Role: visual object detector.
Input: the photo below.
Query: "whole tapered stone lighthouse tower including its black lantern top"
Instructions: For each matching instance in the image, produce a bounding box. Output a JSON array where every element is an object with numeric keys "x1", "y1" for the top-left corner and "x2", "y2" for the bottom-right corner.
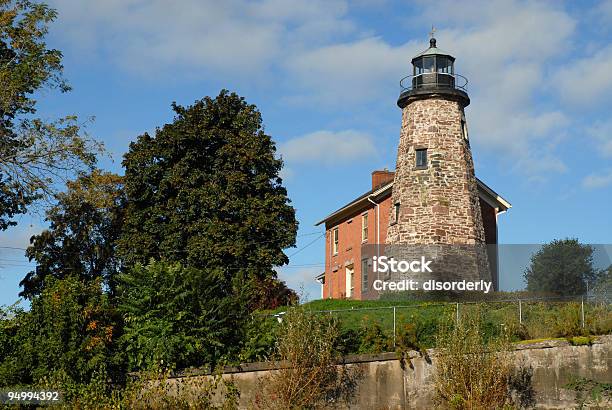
[{"x1": 386, "y1": 38, "x2": 490, "y2": 280}]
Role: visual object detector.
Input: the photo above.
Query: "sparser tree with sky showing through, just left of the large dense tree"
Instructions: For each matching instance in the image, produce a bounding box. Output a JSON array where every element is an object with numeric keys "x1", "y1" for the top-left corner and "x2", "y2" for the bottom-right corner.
[{"x1": 20, "y1": 170, "x2": 124, "y2": 298}]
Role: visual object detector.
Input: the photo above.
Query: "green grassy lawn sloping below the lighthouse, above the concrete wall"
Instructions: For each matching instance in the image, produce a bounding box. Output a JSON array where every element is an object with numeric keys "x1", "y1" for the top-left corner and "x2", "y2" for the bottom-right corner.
[{"x1": 290, "y1": 299, "x2": 612, "y2": 345}]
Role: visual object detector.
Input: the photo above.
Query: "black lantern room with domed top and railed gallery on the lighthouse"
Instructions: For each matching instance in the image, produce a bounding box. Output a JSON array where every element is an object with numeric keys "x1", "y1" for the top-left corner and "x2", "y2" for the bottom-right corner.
[{"x1": 397, "y1": 38, "x2": 470, "y2": 108}]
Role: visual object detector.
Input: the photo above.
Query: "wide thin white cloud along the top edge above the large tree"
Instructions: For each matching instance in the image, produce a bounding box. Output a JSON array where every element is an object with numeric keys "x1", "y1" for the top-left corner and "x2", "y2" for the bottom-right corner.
[{"x1": 51, "y1": 0, "x2": 353, "y2": 78}]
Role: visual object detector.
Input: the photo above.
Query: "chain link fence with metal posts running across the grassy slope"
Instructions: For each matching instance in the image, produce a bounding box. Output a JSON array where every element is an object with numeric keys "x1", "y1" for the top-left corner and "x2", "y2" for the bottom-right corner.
[{"x1": 274, "y1": 294, "x2": 612, "y2": 347}]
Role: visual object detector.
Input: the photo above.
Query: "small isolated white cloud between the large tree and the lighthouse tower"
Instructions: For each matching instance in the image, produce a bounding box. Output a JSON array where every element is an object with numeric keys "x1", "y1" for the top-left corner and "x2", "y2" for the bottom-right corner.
[{"x1": 279, "y1": 130, "x2": 377, "y2": 166}]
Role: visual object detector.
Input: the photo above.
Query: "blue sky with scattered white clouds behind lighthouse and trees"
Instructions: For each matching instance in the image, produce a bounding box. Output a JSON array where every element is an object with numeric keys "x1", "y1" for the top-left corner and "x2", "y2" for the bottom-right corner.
[{"x1": 0, "y1": 0, "x2": 612, "y2": 304}]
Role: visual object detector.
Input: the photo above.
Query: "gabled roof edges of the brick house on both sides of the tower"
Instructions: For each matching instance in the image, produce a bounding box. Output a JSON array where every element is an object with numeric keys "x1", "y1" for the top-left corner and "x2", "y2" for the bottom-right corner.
[{"x1": 315, "y1": 178, "x2": 512, "y2": 226}]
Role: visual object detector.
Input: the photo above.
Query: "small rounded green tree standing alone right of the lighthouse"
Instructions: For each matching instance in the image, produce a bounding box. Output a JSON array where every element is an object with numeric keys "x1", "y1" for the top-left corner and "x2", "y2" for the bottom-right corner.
[{"x1": 524, "y1": 239, "x2": 597, "y2": 296}]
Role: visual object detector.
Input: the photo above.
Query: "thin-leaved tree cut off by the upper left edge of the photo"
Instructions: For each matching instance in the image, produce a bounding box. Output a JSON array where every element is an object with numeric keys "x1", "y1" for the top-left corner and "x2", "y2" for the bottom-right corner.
[{"x1": 0, "y1": 0, "x2": 101, "y2": 230}]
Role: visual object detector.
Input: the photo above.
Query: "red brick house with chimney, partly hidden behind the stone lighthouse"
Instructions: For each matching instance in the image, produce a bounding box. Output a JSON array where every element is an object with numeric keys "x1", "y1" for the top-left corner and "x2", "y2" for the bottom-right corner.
[{"x1": 316, "y1": 170, "x2": 511, "y2": 300}]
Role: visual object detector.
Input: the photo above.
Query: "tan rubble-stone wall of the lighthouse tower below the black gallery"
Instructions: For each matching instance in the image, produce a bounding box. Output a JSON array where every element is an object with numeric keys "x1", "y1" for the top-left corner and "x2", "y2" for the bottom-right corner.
[{"x1": 386, "y1": 94, "x2": 490, "y2": 279}]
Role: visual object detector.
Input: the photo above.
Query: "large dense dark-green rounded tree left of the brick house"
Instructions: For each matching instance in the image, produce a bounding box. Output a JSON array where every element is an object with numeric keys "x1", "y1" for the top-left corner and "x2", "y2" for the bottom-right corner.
[{"x1": 119, "y1": 90, "x2": 297, "y2": 298}]
